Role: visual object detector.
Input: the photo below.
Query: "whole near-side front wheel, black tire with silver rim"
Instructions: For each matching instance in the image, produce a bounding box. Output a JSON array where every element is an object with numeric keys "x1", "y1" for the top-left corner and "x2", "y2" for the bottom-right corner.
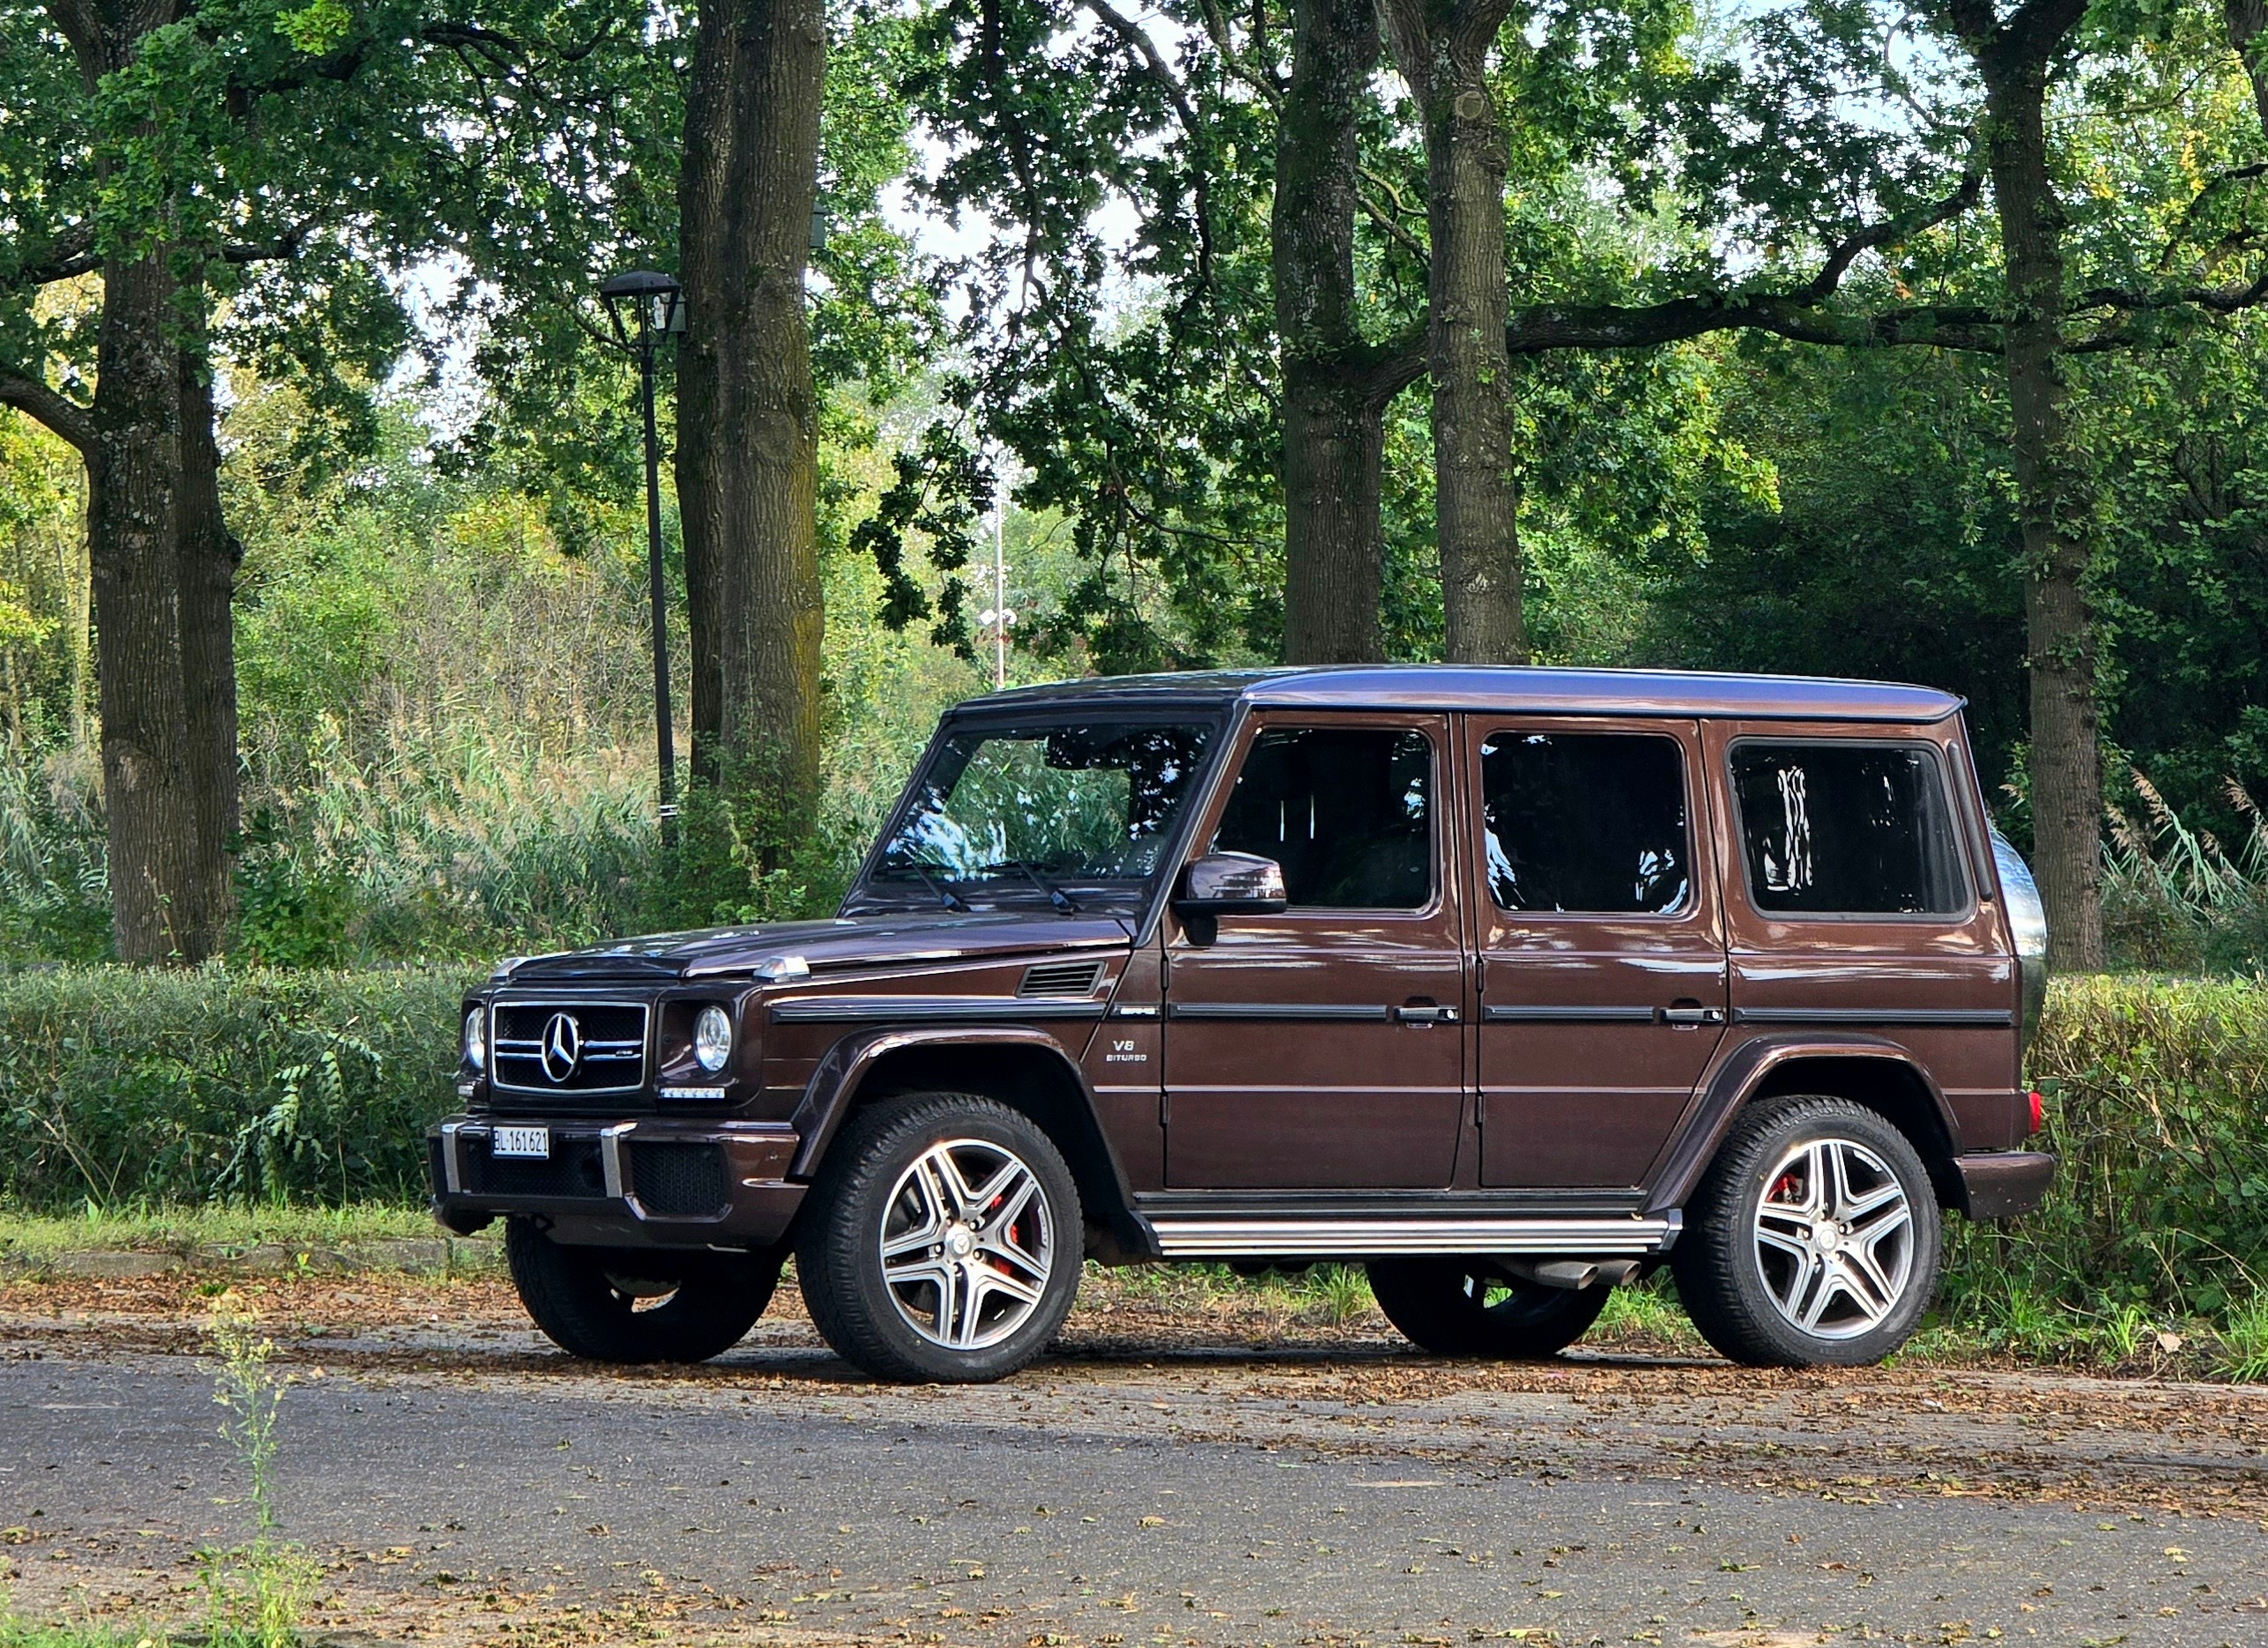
[{"x1": 796, "y1": 1092, "x2": 1084, "y2": 1384}]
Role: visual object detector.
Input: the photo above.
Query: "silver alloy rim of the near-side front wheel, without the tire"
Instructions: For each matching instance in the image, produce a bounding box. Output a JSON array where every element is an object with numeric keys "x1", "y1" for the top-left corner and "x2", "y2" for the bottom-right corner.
[{"x1": 878, "y1": 1139, "x2": 1056, "y2": 1351}]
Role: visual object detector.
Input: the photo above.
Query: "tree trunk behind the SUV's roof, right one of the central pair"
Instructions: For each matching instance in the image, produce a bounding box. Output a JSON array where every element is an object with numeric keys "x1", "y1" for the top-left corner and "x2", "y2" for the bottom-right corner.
[{"x1": 1382, "y1": 0, "x2": 1529, "y2": 663}]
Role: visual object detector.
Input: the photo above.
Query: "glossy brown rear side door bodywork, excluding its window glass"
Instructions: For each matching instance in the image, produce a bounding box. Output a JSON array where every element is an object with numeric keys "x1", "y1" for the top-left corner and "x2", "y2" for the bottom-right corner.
[{"x1": 1458, "y1": 715, "x2": 1728, "y2": 1187}]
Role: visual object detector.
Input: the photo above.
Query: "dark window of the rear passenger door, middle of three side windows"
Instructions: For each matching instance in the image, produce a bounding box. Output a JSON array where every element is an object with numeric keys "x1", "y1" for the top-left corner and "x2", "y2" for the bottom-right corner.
[{"x1": 1481, "y1": 733, "x2": 1692, "y2": 915}]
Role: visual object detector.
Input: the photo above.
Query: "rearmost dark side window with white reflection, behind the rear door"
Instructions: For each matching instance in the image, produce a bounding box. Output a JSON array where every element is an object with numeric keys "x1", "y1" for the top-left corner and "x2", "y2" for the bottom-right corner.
[{"x1": 1733, "y1": 740, "x2": 1968, "y2": 915}]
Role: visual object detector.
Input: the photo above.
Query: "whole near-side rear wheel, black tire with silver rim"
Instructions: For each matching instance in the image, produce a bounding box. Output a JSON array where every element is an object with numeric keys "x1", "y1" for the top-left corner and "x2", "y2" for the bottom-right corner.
[{"x1": 1669, "y1": 1095, "x2": 1944, "y2": 1367}]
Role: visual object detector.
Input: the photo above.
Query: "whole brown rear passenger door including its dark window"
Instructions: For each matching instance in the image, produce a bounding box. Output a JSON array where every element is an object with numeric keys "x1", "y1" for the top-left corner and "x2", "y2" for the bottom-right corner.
[{"x1": 1465, "y1": 715, "x2": 1728, "y2": 1190}]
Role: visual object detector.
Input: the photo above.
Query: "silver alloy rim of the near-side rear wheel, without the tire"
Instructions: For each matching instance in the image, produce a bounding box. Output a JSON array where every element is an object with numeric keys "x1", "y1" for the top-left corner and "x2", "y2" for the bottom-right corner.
[{"x1": 1753, "y1": 1139, "x2": 1914, "y2": 1340}]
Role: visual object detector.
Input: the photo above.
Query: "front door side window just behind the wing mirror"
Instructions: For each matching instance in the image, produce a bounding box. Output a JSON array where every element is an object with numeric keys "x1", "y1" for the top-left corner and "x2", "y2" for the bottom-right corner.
[{"x1": 1213, "y1": 726, "x2": 1434, "y2": 910}]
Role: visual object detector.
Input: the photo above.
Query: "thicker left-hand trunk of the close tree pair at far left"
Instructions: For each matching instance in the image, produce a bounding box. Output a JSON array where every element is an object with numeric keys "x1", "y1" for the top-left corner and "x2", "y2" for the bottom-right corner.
[{"x1": 86, "y1": 252, "x2": 209, "y2": 962}]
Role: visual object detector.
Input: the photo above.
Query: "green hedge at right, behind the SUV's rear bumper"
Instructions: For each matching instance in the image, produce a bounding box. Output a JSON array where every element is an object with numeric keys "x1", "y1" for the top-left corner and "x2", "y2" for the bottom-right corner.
[{"x1": 1951, "y1": 978, "x2": 2268, "y2": 1317}]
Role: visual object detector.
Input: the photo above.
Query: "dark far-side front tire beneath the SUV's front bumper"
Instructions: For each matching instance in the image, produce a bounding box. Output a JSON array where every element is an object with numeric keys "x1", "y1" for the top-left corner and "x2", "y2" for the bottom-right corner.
[{"x1": 503, "y1": 1219, "x2": 787, "y2": 1362}]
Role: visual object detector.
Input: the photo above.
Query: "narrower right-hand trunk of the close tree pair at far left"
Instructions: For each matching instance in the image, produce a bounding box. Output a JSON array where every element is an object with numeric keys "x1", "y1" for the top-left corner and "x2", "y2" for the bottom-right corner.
[{"x1": 174, "y1": 313, "x2": 245, "y2": 961}]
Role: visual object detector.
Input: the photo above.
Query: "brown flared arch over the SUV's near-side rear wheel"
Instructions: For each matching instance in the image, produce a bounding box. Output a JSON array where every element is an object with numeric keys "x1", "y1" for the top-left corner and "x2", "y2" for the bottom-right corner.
[{"x1": 1647, "y1": 1036, "x2": 1967, "y2": 1214}]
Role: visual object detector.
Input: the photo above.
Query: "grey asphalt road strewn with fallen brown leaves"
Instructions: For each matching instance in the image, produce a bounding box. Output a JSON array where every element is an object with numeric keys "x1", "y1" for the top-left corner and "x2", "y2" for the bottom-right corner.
[{"x1": 0, "y1": 1312, "x2": 2268, "y2": 1648}]
